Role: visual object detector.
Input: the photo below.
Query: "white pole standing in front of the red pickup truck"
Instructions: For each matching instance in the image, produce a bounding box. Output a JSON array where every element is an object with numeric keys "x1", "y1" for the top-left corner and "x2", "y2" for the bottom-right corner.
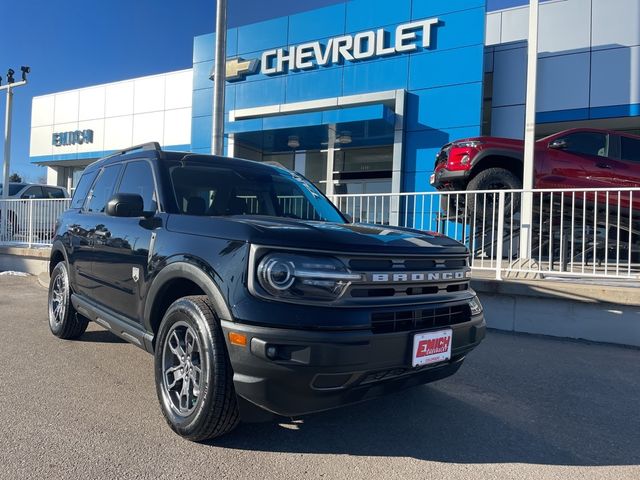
[{"x1": 519, "y1": 0, "x2": 538, "y2": 259}]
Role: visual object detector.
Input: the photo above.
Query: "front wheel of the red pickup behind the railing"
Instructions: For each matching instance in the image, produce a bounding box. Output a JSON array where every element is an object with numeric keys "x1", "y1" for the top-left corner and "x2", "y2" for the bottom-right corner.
[{"x1": 467, "y1": 168, "x2": 522, "y2": 220}]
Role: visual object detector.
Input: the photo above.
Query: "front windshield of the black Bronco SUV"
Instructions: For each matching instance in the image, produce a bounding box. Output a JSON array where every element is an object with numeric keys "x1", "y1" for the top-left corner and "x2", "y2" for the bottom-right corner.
[{"x1": 170, "y1": 164, "x2": 345, "y2": 223}]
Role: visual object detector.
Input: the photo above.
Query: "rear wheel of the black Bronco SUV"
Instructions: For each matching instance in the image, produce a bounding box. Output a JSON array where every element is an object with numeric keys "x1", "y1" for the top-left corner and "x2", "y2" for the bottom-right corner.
[{"x1": 49, "y1": 262, "x2": 89, "y2": 340}]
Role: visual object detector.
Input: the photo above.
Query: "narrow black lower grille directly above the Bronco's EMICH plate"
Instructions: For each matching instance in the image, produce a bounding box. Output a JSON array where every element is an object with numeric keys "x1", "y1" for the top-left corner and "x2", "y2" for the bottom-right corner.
[{"x1": 371, "y1": 304, "x2": 471, "y2": 333}]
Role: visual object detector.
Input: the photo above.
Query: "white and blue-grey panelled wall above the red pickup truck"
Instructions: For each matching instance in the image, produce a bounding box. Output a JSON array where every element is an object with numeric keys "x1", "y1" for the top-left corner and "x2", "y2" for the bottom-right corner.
[{"x1": 486, "y1": 0, "x2": 640, "y2": 138}]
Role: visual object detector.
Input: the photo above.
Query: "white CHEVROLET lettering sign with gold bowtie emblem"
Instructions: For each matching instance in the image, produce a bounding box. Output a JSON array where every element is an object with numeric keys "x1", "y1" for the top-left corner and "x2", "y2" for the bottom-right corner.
[{"x1": 220, "y1": 18, "x2": 439, "y2": 81}]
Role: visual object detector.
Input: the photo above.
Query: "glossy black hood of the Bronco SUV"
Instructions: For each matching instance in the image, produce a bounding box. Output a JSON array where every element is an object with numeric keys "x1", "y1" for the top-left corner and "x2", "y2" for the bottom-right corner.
[{"x1": 167, "y1": 215, "x2": 467, "y2": 255}]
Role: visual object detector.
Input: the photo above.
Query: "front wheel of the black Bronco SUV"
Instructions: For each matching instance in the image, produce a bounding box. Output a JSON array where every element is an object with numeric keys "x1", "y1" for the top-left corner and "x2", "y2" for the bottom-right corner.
[{"x1": 155, "y1": 296, "x2": 240, "y2": 441}]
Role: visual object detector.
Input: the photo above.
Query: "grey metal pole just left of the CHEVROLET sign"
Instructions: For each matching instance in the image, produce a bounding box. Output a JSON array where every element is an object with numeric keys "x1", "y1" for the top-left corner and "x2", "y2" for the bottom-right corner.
[{"x1": 211, "y1": 0, "x2": 227, "y2": 155}]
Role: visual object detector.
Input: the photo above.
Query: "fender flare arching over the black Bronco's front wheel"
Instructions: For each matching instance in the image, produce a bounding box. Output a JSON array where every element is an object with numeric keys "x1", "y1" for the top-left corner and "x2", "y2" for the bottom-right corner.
[{"x1": 143, "y1": 260, "x2": 233, "y2": 333}]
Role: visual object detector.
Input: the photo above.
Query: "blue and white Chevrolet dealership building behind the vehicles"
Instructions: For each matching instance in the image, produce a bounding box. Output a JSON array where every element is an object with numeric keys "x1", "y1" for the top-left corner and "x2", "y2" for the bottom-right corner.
[{"x1": 30, "y1": 0, "x2": 640, "y2": 194}]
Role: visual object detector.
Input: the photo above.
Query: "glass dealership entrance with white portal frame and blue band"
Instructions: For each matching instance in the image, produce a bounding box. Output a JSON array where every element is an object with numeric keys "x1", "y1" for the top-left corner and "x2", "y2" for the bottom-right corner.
[{"x1": 226, "y1": 90, "x2": 405, "y2": 196}]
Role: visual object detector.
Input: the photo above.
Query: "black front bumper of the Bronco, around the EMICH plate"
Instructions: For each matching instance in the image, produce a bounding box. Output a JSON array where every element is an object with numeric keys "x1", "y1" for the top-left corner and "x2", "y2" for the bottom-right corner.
[{"x1": 222, "y1": 314, "x2": 486, "y2": 417}]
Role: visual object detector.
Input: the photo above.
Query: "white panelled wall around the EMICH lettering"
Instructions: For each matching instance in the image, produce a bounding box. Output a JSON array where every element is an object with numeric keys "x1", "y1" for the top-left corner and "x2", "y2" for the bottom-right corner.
[{"x1": 30, "y1": 70, "x2": 193, "y2": 161}]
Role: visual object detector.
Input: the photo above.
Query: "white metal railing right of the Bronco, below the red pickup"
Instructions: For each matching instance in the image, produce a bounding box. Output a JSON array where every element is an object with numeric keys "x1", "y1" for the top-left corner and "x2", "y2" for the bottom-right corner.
[{"x1": 332, "y1": 188, "x2": 640, "y2": 280}]
